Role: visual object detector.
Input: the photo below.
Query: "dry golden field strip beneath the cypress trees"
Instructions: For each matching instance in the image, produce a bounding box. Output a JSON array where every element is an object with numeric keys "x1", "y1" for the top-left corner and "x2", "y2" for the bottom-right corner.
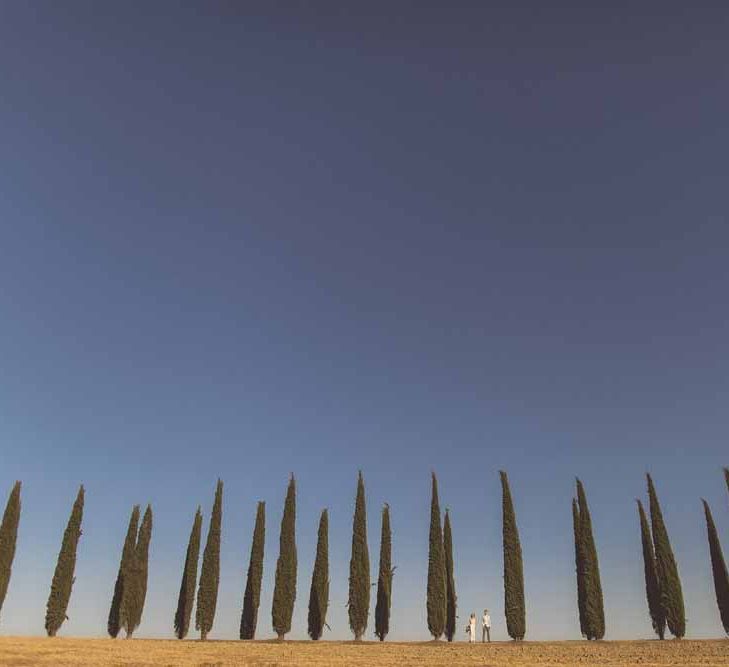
[{"x1": 0, "y1": 637, "x2": 729, "y2": 667}]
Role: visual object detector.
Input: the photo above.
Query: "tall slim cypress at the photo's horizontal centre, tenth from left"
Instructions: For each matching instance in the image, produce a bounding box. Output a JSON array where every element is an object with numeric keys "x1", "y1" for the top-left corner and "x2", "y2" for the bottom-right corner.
[{"x1": 348, "y1": 470, "x2": 370, "y2": 641}]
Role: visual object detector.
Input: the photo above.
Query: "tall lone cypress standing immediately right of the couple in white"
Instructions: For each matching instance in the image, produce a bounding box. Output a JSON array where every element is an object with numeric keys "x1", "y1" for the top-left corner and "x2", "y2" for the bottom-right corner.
[{"x1": 499, "y1": 470, "x2": 526, "y2": 641}]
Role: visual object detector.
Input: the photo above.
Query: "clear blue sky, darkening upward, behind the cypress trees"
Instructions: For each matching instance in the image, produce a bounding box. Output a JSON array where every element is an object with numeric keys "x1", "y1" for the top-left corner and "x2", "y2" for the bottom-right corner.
[{"x1": 0, "y1": 1, "x2": 729, "y2": 640}]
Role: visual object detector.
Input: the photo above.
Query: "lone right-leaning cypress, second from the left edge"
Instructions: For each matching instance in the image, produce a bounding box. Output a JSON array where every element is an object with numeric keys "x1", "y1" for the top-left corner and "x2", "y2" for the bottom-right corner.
[{"x1": 46, "y1": 485, "x2": 84, "y2": 637}]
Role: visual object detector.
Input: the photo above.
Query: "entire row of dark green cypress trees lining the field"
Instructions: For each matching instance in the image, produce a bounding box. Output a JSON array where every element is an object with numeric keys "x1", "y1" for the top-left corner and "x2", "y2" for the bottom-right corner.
[{"x1": 0, "y1": 468, "x2": 729, "y2": 641}]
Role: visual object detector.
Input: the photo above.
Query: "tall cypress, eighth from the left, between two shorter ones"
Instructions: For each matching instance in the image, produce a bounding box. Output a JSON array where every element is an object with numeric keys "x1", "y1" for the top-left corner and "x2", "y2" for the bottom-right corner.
[{"x1": 271, "y1": 474, "x2": 297, "y2": 640}]
